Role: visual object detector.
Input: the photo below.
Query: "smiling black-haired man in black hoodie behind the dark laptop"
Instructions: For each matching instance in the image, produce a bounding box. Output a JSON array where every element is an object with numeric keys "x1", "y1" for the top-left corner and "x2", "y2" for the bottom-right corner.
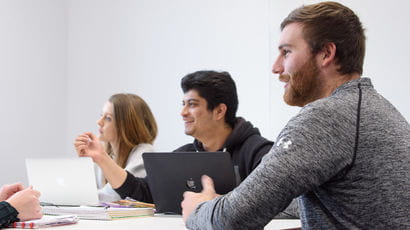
[{"x1": 175, "y1": 71, "x2": 273, "y2": 181}]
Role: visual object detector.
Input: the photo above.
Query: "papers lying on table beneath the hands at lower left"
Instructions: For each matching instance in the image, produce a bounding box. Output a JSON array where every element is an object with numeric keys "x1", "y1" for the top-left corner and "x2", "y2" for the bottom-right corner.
[{"x1": 9, "y1": 215, "x2": 78, "y2": 228}]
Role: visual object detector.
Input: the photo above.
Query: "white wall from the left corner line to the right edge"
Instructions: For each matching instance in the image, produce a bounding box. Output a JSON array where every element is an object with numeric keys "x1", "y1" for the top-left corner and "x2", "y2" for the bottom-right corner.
[{"x1": 67, "y1": 0, "x2": 410, "y2": 155}]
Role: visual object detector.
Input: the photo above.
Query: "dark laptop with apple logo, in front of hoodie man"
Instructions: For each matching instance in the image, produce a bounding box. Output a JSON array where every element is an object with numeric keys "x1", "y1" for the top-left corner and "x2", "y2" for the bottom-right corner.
[{"x1": 142, "y1": 152, "x2": 237, "y2": 214}]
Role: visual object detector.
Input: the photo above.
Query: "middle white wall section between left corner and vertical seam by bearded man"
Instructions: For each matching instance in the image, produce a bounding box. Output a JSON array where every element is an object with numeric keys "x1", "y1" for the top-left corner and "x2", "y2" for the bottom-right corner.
[{"x1": 67, "y1": 0, "x2": 271, "y2": 155}]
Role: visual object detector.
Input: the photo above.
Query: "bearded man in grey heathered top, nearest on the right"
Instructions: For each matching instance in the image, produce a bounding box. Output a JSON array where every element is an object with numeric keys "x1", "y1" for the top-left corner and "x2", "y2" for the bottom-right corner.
[{"x1": 181, "y1": 2, "x2": 410, "y2": 229}]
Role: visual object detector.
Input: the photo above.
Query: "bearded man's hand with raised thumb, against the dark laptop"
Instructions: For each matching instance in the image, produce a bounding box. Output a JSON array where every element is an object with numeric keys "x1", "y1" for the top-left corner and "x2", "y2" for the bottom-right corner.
[{"x1": 181, "y1": 175, "x2": 220, "y2": 222}]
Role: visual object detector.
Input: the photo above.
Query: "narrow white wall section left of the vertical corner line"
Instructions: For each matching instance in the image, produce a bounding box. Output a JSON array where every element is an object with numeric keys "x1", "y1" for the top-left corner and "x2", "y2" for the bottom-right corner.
[{"x1": 0, "y1": 0, "x2": 67, "y2": 184}]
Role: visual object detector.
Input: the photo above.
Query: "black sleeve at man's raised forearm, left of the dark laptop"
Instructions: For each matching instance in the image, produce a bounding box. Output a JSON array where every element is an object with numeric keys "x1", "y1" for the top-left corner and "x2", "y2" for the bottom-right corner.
[{"x1": 114, "y1": 171, "x2": 153, "y2": 203}]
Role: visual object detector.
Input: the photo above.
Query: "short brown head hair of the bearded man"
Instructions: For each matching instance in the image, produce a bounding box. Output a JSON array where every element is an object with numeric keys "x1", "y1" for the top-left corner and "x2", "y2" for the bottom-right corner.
[{"x1": 281, "y1": 2, "x2": 366, "y2": 75}]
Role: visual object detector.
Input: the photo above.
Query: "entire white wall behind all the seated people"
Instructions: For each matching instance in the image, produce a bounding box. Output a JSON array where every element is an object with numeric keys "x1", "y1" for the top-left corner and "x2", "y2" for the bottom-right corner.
[{"x1": 0, "y1": 0, "x2": 410, "y2": 183}]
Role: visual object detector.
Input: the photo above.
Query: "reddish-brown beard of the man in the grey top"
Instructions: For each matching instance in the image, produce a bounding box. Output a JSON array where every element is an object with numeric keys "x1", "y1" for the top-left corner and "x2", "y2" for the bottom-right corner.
[{"x1": 279, "y1": 57, "x2": 321, "y2": 107}]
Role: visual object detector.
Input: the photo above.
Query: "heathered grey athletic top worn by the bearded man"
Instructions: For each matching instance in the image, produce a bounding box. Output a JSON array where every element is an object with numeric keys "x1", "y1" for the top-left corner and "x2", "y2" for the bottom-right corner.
[{"x1": 186, "y1": 78, "x2": 410, "y2": 229}]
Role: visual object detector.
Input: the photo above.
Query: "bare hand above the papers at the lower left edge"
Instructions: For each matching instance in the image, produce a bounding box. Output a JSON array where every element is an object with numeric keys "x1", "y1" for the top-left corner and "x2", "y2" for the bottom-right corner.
[{"x1": 6, "y1": 186, "x2": 43, "y2": 221}]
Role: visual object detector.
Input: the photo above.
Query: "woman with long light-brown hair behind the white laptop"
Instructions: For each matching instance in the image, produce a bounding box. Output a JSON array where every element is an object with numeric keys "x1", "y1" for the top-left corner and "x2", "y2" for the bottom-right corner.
[{"x1": 74, "y1": 94, "x2": 157, "y2": 201}]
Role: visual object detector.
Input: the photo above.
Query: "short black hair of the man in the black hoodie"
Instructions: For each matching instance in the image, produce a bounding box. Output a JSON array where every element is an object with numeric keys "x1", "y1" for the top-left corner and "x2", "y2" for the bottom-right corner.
[{"x1": 181, "y1": 71, "x2": 238, "y2": 128}]
